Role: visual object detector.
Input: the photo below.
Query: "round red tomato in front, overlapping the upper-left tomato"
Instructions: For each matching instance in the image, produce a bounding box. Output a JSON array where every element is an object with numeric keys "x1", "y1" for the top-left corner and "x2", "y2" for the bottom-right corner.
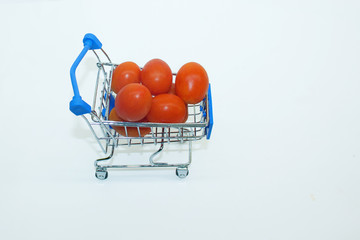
[{"x1": 115, "y1": 83, "x2": 152, "y2": 122}]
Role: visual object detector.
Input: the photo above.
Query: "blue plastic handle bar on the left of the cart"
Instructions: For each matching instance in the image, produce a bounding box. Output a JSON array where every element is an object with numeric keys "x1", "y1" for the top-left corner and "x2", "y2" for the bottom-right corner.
[{"x1": 70, "y1": 33, "x2": 102, "y2": 116}]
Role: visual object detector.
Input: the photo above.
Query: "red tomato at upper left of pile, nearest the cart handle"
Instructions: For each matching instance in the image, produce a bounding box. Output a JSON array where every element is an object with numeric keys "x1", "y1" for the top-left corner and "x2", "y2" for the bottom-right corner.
[{"x1": 111, "y1": 62, "x2": 141, "y2": 93}]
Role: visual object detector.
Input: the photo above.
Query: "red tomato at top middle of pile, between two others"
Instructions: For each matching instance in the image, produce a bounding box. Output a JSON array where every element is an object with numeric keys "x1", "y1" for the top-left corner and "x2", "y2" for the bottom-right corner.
[{"x1": 141, "y1": 59, "x2": 172, "y2": 95}]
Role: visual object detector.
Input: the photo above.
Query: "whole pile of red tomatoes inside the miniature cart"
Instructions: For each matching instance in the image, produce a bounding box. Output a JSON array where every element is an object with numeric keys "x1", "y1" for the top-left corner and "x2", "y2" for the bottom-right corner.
[{"x1": 109, "y1": 59, "x2": 209, "y2": 137}]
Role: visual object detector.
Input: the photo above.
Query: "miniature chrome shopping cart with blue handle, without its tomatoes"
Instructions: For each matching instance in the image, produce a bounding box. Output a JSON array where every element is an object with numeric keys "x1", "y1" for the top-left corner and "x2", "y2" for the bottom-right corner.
[{"x1": 70, "y1": 33, "x2": 213, "y2": 180}]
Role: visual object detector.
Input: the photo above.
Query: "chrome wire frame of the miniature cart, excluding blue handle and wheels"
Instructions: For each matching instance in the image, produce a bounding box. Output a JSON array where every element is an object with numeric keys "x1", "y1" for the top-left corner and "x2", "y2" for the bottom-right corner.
[{"x1": 82, "y1": 49, "x2": 209, "y2": 170}]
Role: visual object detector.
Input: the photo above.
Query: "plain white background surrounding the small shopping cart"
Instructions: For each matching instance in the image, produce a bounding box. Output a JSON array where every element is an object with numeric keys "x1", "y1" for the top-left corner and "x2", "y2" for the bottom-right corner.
[{"x1": 0, "y1": 0, "x2": 360, "y2": 240}]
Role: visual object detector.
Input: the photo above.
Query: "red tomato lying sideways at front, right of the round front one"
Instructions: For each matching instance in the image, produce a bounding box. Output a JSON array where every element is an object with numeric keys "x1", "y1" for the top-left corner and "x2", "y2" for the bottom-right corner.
[{"x1": 146, "y1": 93, "x2": 186, "y2": 123}]
